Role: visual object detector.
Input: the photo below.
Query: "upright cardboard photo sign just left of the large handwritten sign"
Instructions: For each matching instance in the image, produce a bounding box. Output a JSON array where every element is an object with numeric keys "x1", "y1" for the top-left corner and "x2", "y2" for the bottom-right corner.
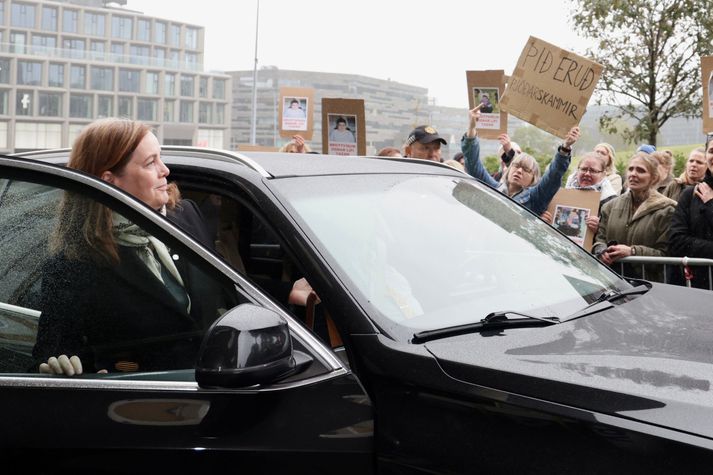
[{"x1": 465, "y1": 70, "x2": 508, "y2": 139}]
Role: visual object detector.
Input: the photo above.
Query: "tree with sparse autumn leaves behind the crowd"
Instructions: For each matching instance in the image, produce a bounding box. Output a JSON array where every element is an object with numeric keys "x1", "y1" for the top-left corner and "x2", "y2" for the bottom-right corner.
[{"x1": 570, "y1": 0, "x2": 713, "y2": 144}]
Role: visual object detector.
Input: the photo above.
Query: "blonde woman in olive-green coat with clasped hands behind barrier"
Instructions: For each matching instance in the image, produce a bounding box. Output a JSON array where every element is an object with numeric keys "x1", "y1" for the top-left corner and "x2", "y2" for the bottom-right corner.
[{"x1": 592, "y1": 152, "x2": 676, "y2": 280}]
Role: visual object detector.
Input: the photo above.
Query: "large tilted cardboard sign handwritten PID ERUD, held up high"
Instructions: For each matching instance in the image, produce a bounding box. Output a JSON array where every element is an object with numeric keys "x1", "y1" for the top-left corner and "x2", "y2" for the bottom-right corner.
[{"x1": 500, "y1": 36, "x2": 603, "y2": 138}]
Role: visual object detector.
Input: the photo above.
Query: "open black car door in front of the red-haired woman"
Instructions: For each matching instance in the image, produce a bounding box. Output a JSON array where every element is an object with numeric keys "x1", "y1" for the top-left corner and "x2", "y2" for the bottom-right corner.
[{"x1": 0, "y1": 159, "x2": 374, "y2": 473}]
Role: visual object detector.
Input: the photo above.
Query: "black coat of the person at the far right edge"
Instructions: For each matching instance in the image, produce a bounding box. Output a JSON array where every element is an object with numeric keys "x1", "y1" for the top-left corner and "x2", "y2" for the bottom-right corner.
[{"x1": 668, "y1": 186, "x2": 713, "y2": 289}]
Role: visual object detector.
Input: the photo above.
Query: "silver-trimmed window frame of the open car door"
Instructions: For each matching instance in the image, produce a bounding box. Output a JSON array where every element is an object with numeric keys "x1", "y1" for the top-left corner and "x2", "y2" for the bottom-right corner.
[{"x1": 0, "y1": 156, "x2": 349, "y2": 391}]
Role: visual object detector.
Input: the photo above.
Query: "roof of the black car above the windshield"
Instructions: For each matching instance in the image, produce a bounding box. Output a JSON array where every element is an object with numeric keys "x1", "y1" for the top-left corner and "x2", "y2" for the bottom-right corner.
[{"x1": 13, "y1": 145, "x2": 463, "y2": 178}]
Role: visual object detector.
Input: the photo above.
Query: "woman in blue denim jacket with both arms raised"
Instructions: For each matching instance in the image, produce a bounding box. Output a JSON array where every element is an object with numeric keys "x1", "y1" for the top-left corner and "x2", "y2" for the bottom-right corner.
[{"x1": 461, "y1": 106, "x2": 579, "y2": 215}]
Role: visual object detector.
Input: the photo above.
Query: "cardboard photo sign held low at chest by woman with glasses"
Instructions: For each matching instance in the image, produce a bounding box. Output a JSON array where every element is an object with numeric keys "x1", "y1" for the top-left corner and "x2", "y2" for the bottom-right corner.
[{"x1": 547, "y1": 188, "x2": 602, "y2": 251}]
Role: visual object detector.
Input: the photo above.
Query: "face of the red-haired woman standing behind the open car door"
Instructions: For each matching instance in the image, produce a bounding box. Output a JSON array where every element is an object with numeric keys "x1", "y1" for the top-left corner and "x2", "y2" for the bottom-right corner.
[{"x1": 107, "y1": 133, "x2": 169, "y2": 209}]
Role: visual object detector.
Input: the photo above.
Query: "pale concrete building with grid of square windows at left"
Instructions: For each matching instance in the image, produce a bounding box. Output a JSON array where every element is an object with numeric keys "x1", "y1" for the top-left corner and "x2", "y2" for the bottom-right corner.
[{"x1": 0, "y1": 0, "x2": 232, "y2": 152}]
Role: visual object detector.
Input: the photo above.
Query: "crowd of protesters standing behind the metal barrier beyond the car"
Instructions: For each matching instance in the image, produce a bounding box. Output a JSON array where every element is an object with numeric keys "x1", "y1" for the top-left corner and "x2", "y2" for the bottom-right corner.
[{"x1": 379, "y1": 106, "x2": 713, "y2": 289}]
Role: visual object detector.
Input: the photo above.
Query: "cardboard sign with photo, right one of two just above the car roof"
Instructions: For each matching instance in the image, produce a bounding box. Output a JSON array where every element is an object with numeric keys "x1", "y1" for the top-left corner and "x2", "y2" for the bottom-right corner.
[{"x1": 322, "y1": 98, "x2": 366, "y2": 155}]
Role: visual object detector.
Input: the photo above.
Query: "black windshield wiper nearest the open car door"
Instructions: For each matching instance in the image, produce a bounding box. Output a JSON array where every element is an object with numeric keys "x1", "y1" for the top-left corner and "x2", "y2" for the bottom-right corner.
[{"x1": 411, "y1": 310, "x2": 560, "y2": 343}]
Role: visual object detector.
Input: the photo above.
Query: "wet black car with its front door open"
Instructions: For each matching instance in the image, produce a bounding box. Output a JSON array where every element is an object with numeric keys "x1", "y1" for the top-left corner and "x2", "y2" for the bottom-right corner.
[{"x1": 0, "y1": 147, "x2": 713, "y2": 474}]
